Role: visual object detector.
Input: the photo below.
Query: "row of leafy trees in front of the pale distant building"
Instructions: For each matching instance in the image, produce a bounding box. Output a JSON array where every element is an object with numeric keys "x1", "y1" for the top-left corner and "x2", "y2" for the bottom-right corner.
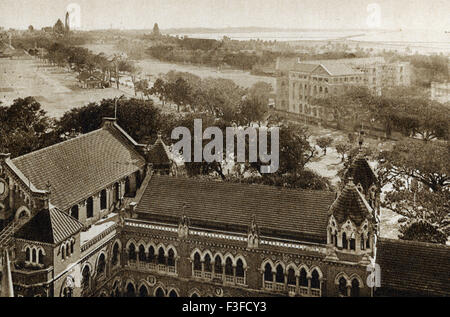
[{"x1": 312, "y1": 87, "x2": 450, "y2": 141}]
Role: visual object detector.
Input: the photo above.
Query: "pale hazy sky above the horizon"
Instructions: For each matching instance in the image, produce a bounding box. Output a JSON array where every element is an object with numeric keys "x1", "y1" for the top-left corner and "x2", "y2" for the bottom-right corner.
[{"x1": 0, "y1": 0, "x2": 450, "y2": 30}]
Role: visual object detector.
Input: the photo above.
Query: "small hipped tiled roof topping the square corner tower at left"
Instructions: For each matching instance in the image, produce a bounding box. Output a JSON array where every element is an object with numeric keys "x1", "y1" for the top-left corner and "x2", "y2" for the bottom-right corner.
[{"x1": 14, "y1": 207, "x2": 83, "y2": 244}]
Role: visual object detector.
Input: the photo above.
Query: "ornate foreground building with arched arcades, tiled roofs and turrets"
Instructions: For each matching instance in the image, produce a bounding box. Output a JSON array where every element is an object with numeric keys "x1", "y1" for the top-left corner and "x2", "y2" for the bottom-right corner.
[{"x1": 0, "y1": 119, "x2": 450, "y2": 297}]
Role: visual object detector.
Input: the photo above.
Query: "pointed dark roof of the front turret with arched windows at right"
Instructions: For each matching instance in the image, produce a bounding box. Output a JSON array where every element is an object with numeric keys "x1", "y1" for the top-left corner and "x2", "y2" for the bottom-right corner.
[{"x1": 330, "y1": 181, "x2": 372, "y2": 226}]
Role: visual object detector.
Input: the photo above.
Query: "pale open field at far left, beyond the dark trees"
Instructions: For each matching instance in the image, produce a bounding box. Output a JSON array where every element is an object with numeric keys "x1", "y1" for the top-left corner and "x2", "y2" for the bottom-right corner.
[{"x1": 0, "y1": 58, "x2": 134, "y2": 117}]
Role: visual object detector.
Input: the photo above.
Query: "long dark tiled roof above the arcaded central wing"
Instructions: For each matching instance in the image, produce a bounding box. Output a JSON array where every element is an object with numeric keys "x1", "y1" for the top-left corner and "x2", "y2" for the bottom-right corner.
[{"x1": 136, "y1": 175, "x2": 335, "y2": 243}]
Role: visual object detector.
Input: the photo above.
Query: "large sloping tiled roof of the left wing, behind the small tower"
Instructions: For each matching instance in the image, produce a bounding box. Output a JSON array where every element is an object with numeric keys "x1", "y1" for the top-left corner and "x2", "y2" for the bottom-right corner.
[{"x1": 12, "y1": 127, "x2": 145, "y2": 210}]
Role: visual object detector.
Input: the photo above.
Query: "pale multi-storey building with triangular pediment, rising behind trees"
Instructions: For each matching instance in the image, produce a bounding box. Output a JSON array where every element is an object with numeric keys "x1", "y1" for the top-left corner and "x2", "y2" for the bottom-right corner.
[{"x1": 275, "y1": 57, "x2": 410, "y2": 122}]
